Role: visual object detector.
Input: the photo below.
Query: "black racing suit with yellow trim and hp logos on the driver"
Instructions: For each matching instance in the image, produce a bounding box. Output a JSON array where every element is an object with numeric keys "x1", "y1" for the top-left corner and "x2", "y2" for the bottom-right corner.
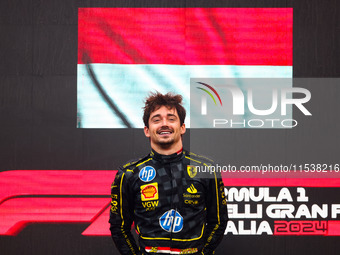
[{"x1": 109, "y1": 150, "x2": 228, "y2": 254}]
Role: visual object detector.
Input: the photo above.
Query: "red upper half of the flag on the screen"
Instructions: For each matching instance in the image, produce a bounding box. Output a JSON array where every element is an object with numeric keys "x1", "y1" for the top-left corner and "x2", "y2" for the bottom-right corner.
[{"x1": 78, "y1": 8, "x2": 293, "y2": 66}]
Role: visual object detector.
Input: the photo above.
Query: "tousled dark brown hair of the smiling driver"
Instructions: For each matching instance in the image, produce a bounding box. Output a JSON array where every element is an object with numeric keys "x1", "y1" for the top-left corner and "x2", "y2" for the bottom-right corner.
[{"x1": 143, "y1": 92, "x2": 186, "y2": 128}]
